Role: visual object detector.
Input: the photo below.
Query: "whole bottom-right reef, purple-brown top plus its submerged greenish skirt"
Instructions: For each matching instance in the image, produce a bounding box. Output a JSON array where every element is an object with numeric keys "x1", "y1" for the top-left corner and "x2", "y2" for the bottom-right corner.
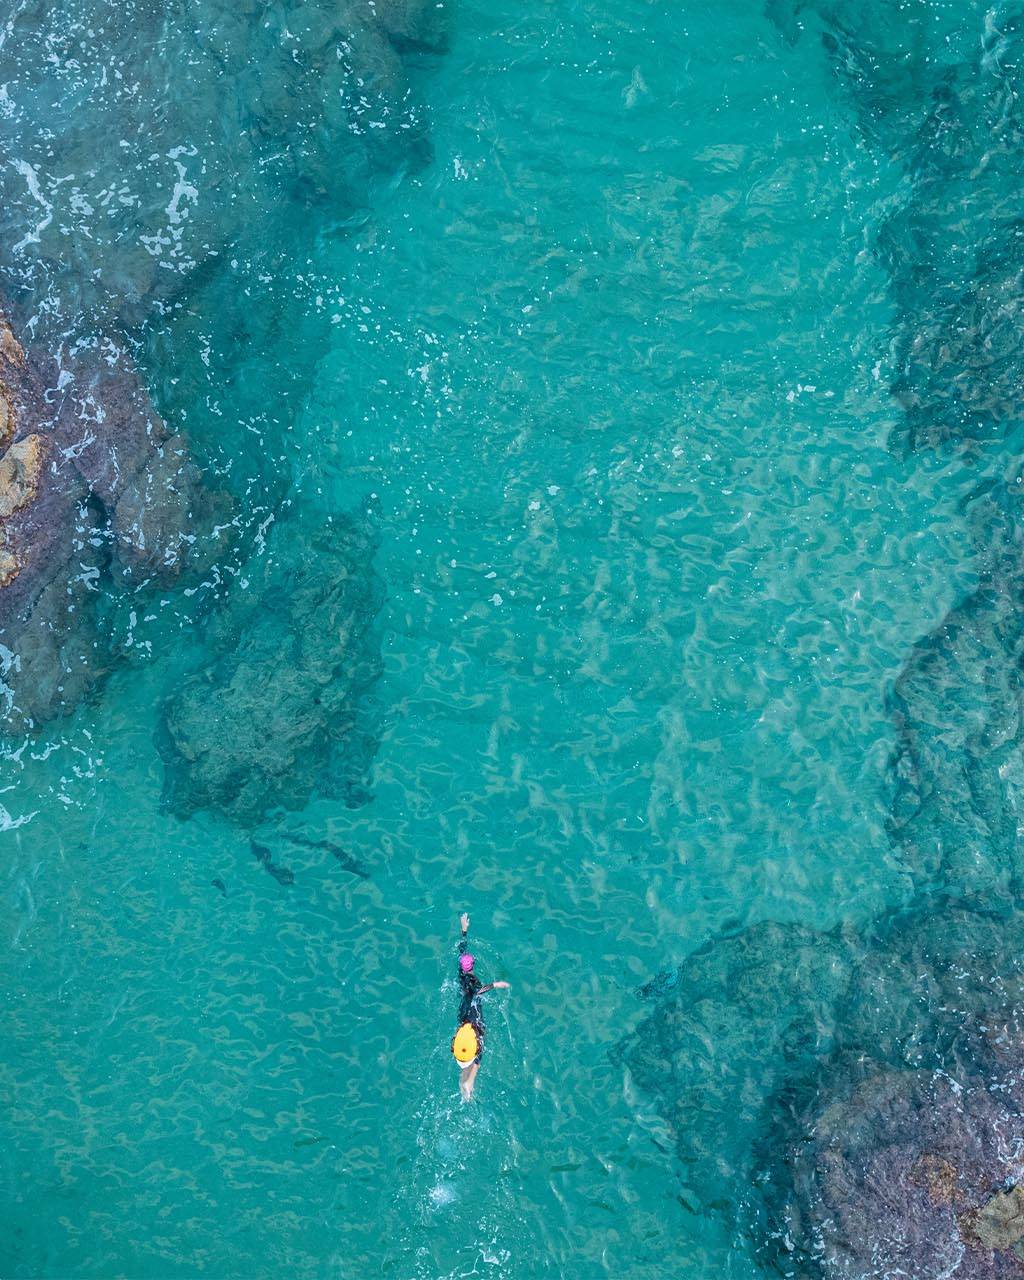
[{"x1": 617, "y1": 901, "x2": 1024, "y2": 1280}]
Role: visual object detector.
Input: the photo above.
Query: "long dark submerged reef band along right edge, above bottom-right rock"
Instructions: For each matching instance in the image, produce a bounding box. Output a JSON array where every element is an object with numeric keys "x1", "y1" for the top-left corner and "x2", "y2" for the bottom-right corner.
[{"x1": 767, "y1": 0, "x2": 1024, "y2": 892}]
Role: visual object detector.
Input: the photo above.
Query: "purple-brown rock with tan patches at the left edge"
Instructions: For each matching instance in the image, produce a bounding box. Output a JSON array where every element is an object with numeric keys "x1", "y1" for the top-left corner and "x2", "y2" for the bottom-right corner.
[{"x1": 0, "y1": 303, "x2": 227, "y2": 733}]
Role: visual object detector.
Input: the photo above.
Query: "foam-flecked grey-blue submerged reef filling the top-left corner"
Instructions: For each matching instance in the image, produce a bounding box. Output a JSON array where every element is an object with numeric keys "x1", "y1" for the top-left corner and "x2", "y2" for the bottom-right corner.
[{"x1": 0, "y1": 0, "x2": 447, "y2": 328}]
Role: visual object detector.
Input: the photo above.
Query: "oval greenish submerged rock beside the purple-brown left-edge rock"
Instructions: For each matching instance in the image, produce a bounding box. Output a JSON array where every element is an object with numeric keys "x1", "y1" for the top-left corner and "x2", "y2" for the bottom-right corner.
[{"x1": 161, "y1": 518, "x2": 380, "y2": 820}]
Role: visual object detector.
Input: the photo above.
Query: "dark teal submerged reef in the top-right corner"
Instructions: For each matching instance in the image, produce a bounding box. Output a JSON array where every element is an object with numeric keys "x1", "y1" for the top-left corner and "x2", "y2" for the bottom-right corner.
[{"x1": 768, "y1": 0, "x2": 1024, "y2": 453}]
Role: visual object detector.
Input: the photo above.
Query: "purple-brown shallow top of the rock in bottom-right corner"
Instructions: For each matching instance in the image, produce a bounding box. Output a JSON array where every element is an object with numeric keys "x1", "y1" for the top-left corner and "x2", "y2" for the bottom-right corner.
[{"x1": 787, "y1": 1046, "x2": 1024, "y2": 1280}]
